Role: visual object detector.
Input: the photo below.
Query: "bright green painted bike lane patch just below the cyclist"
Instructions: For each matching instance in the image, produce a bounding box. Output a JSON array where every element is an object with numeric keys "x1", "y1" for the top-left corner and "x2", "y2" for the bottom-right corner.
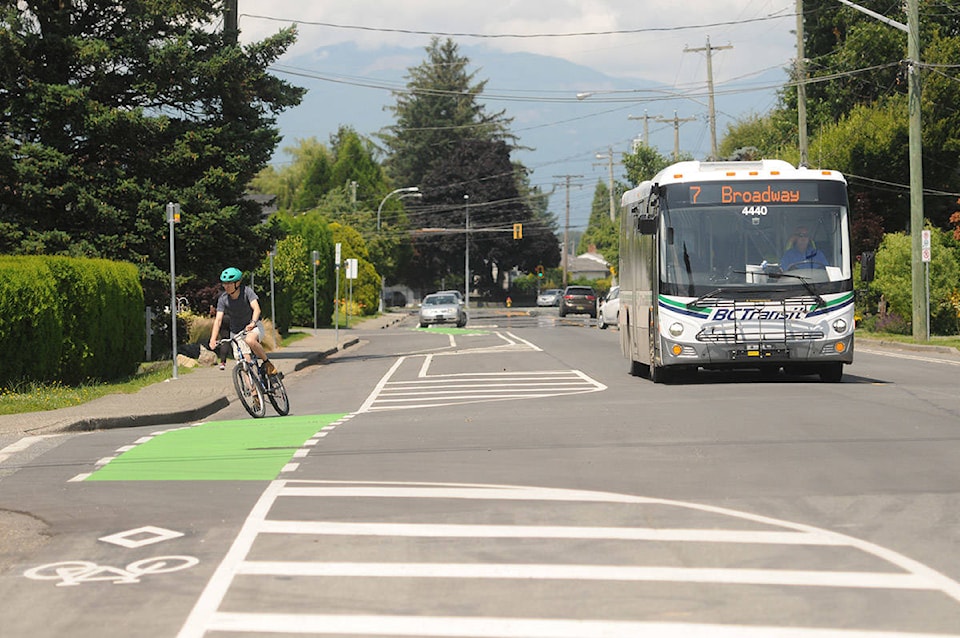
[{"x1": 85, "y1": 414, "x2": 345, "y2": 481}]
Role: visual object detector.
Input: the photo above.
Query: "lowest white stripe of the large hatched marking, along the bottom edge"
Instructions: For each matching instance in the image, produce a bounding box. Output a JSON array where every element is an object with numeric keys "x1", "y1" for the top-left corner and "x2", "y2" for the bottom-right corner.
[{"x1": 204, "y1": 612, "x2": 957, "y2": 638}]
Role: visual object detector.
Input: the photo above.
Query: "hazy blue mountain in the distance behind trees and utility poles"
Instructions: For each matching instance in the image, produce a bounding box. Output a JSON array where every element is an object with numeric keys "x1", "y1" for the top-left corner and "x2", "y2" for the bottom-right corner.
[{"x1": 273, "y1": 43, "x2": 786, "y2": 228}]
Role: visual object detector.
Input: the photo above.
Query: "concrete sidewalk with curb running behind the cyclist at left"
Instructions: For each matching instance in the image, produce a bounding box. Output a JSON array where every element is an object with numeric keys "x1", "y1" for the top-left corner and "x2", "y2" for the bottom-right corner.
[{"x1": 0, "y1": 312, "x2": 409, "y2": 435}]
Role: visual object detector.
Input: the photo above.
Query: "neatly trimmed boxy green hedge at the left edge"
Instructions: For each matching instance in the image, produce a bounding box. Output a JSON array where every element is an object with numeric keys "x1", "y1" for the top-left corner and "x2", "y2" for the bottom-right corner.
[{"x1": 0, "y1": 256, "x2": 146, "y2": 387}]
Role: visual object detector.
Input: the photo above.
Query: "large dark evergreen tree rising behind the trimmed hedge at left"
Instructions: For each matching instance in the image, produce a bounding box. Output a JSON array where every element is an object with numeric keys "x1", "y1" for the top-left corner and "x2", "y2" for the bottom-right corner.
[{"x1": 0, "y1": 0, "x2": 302, "y2": 303}]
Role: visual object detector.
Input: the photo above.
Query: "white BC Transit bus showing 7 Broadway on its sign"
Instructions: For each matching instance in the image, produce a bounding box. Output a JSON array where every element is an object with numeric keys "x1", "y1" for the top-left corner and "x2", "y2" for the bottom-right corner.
[{"x1": 618, "y1": 160, "x2": 854, "y2": 383}]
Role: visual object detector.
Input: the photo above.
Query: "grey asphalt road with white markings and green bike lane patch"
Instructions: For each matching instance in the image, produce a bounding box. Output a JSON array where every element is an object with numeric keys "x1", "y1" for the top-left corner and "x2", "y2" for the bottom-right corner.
[{"x1": 0, "y1": 310, "x2": 960, "y2": 638}]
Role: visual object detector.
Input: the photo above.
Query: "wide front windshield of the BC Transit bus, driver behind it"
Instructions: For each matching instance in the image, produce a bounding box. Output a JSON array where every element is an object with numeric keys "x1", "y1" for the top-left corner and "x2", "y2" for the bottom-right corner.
[{"x1": 659, "y1": 182, "x2": 852, "y2": 296}]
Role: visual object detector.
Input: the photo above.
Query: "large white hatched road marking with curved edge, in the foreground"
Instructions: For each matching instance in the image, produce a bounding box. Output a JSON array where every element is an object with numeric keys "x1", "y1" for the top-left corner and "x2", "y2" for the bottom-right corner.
[{"x1": 179, "y1": 480, "x2": 960, "y2": 638}]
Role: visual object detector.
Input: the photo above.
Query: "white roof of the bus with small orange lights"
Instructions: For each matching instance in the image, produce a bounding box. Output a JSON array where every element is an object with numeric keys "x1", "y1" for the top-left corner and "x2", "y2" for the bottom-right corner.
[{"x1": 621, "y1": 159, "x2": 847, "y2": 206}]
